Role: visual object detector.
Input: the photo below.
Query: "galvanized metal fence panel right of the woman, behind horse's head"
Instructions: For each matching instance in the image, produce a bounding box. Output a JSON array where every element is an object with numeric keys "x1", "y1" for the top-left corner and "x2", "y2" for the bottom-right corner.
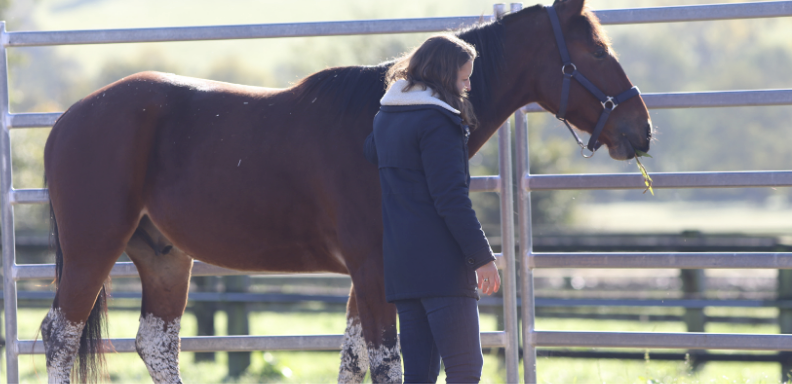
[{"x1": 515, "y1": 1, "x2": 792, "y2": 383}]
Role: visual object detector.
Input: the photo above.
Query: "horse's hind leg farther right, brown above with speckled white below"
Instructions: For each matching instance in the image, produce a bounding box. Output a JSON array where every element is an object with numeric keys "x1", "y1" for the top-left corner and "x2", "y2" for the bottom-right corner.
[{"x1": 126, "y1": 216, "x2": 193, "y2": 383}]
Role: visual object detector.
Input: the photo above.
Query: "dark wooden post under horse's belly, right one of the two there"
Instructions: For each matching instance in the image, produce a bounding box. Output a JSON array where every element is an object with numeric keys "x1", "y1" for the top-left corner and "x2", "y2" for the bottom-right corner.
[{"x1": 223, "y1": 276, "x2": 250, "y2": 377}]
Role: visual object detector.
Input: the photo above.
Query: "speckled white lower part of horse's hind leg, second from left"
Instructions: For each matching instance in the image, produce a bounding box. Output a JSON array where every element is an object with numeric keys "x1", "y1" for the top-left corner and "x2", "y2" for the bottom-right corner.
[{"x1": 135, "y1": 313, "x2": 182, "y2": 384}]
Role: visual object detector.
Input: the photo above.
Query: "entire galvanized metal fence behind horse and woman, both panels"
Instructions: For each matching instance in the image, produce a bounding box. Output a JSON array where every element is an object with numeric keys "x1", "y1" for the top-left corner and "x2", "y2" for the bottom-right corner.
[{"x1": 0, "y1": 1, "x2": 792, "y2": 383}]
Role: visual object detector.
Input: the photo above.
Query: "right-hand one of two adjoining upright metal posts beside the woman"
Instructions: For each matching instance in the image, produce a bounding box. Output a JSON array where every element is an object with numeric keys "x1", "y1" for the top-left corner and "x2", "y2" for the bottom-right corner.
[{"x1": 514, "y1": 110, "x2": 536, "y2": 384}]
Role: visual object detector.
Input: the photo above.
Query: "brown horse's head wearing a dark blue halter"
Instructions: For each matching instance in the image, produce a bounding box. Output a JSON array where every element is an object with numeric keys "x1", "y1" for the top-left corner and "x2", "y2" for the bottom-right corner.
[{"x1": 504, "y1": 0, "x2": 652, "y2": 160}]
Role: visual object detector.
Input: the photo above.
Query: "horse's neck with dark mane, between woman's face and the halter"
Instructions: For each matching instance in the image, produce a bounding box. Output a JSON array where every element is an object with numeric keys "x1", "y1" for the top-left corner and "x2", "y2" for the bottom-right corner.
[{"x1": 468, "y1": 7, "x2": 557, "y2": 156}]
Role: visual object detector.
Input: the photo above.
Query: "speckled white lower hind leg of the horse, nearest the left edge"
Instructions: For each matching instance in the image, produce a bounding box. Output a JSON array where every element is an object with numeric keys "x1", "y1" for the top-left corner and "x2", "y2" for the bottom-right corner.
[{"x1": 41, "y1": 308, "x2": 85, "y2": 383}]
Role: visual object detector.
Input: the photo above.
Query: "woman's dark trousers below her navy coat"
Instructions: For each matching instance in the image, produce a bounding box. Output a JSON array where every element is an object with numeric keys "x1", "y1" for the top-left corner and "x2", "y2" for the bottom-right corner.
[{"x1": 394, "y1": 297, "x2": 484, "y2": 383}]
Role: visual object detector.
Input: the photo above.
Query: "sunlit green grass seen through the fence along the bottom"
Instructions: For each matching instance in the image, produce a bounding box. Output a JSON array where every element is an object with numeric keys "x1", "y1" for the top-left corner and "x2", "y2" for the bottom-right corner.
[{"x1": 3, "y1": 309, "x2": 781, "y2": 384}]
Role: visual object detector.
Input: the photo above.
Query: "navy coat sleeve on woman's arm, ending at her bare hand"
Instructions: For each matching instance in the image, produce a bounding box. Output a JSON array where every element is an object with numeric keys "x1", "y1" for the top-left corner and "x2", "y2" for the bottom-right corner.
[{"x1": 420, "y1": 118, "x2": 495, "y2": 269}]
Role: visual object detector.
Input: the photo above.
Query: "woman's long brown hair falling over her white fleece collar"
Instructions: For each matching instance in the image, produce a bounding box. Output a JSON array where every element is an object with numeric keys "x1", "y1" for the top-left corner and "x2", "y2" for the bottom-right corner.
[{"x1": 385, "y1": 34, "x2": 478, "y2": 129}]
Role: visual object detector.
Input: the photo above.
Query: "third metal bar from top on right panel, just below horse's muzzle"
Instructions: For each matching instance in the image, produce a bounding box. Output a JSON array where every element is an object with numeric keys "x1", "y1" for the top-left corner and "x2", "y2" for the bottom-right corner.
[{"x1": 522, "y1": 171, "x2": 792, "y2": 191}]
